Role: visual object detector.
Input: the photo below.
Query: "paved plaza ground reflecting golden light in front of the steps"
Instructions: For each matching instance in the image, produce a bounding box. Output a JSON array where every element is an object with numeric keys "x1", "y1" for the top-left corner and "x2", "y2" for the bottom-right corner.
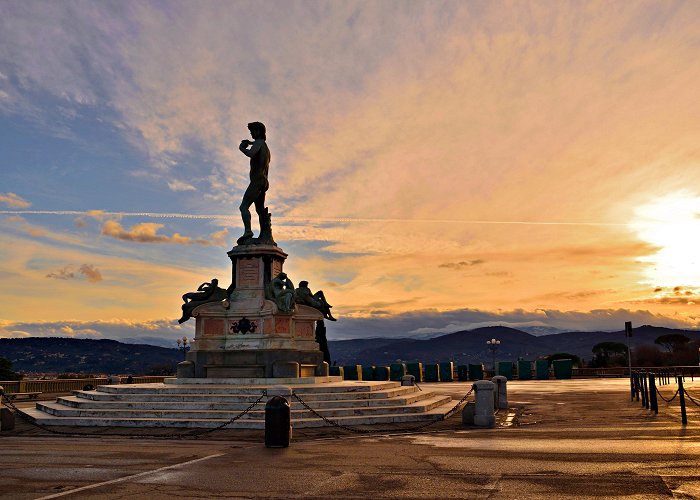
[{"x1": 0, "y1": 379, "x2": 700, "y2": 499}]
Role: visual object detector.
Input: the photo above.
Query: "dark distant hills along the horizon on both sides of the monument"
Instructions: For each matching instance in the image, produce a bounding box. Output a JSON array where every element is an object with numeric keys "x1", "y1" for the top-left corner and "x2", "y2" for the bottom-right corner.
[{"x1": 0, "y1": 325, "x2": 700, "y2": 375}]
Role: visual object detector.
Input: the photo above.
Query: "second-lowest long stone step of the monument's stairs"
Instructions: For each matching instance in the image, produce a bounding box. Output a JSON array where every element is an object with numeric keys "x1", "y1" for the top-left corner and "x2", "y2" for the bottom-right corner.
[{"x1": 36, "y1": 396, "x2": 451, "y2": 420}]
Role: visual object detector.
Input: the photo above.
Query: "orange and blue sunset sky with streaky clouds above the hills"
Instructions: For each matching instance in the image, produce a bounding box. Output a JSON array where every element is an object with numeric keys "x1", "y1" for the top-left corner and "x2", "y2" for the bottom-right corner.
[{"x1": 0, "y1": 0, "x2": 700, "y2": 344}]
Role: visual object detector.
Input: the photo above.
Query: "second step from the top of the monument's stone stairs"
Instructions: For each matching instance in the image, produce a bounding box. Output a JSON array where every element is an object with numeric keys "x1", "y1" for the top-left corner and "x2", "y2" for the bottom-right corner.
[{"x1": 73, "y1": 385, "x2": 419, "y2": 403}]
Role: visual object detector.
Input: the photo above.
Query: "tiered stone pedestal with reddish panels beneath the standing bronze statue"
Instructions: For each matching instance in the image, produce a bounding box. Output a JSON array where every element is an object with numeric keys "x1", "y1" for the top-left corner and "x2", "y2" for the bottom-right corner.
[{"x1": 183, "y1": 245, "x2": 324, "y2": 379}]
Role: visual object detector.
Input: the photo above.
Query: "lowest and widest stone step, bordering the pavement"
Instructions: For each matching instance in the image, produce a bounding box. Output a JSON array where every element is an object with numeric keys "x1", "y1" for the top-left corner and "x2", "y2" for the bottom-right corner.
[{"x1": 23, "y1": 401, "x2": 451, "y2": 429}]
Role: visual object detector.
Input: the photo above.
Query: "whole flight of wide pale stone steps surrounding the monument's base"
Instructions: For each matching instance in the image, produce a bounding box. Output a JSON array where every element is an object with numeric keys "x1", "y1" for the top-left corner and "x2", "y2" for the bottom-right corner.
[{"x1": 24, "y1": 381, "x2": 452, "y2": 429}]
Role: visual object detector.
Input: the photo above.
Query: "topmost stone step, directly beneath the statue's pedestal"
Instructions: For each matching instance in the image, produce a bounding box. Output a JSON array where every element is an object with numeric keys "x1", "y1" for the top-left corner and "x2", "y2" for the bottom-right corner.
[{"x1": 96, "y1": 380, "x2": 401, "y2": 394}]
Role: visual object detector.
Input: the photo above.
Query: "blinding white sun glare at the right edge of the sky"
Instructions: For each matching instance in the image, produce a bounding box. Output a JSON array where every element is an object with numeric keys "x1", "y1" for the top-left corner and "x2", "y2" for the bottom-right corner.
[{"x1": 632, "y1": 192, "x2": 700, "y2": 287}]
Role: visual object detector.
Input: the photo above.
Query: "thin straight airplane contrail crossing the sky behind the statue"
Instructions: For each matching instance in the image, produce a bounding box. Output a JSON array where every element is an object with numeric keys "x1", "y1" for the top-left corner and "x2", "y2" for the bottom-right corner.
[{"x1": 0, "y1": 210, "x2": 628, "y2": 227}]
